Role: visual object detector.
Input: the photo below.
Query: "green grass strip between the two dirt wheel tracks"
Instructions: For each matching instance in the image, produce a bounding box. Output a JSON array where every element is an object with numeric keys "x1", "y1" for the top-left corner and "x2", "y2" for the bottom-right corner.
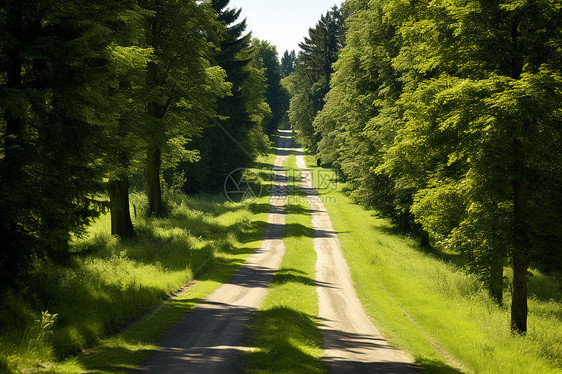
[{"x1": 244, "y1": 156, "x2": 325, "y2": 373}]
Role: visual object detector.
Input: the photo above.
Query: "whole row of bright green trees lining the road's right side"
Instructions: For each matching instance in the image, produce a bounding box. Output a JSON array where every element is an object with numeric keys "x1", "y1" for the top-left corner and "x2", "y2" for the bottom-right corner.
[{"x1": 310, "y1": 0, "x2": 562, "y2": 332}]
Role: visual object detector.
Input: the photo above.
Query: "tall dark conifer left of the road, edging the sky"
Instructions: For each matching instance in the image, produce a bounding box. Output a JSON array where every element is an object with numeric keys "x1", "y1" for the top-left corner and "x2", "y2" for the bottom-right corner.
[{"x1": 181, "y1": 0, "x2": 270, "y2": 192}]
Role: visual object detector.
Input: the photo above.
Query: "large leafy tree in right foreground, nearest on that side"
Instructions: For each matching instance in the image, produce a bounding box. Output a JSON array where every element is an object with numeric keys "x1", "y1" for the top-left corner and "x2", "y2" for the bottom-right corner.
[{"x1": 384, "y1": 1, "x2": 562, "y2": 332}]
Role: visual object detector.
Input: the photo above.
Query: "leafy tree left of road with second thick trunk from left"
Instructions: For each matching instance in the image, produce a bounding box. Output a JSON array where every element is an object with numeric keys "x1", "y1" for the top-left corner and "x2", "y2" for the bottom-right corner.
[{"x1": 140, "y1": 0, "x2": 228, "y2": 217}]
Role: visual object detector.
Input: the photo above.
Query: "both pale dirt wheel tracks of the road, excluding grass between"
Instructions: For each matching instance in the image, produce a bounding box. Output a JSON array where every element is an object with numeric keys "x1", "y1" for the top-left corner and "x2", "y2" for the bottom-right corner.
[{"x1": 134, "y1": 131, "x2": 415, "y2": 374}]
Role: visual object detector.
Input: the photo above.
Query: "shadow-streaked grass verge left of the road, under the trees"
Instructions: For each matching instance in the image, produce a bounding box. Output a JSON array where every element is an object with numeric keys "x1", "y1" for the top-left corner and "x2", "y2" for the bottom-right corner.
[{"x1": 0, "y1": 150, "x2": 275, "y2": 373}]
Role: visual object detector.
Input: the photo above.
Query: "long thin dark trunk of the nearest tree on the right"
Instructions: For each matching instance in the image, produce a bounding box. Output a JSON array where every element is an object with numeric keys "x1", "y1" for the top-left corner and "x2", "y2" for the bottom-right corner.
[{"x1": 511, "y1": 140, "x2": 529, "y2": 334}]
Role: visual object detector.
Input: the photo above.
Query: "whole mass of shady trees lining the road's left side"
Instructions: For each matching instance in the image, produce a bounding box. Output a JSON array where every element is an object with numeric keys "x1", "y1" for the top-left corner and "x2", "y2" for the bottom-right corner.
[{"x1": 0, "y1": 0, "x2": 272, "y2": 288}]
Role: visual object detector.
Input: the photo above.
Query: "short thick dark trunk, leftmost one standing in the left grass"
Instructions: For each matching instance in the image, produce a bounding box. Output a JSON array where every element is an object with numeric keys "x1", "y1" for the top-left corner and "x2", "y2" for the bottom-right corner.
[{"x1": 108, "y1": 178, "x2": 135, "y2": 238}]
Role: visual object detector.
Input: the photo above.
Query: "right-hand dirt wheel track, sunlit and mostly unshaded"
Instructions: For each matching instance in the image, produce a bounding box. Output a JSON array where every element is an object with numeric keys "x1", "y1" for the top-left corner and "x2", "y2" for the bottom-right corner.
[{"x1": 297, "y1": 150, "x2": 416, "y2": 374}]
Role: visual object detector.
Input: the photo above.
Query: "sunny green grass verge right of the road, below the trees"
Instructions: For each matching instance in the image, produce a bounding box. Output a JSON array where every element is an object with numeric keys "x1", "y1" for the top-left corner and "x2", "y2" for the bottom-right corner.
[{"x1": 307, "y1": 158, "x2": 562, "y2": 373}]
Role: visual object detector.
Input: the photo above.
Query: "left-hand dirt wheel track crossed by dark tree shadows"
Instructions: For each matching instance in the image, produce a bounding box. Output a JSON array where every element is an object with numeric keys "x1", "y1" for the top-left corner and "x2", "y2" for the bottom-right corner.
[{"x1": 134, "y1": 132, "x2": 291, "y2": 374}]
